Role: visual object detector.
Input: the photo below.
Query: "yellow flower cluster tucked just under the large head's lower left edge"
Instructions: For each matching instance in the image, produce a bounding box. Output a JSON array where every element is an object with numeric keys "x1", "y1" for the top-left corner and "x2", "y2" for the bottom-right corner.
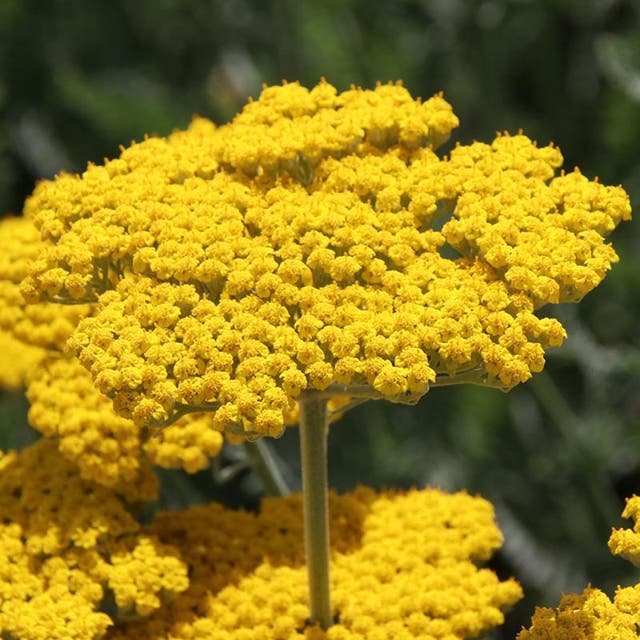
[{"x1": 27, "y1": 357, "x2": 223, "y2": 482}]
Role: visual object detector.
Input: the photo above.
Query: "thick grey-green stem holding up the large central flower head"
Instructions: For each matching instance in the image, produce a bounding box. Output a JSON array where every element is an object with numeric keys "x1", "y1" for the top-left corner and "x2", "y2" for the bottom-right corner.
[{"x1": 299, "y1": 395, "x2": 333, "y2": 629}]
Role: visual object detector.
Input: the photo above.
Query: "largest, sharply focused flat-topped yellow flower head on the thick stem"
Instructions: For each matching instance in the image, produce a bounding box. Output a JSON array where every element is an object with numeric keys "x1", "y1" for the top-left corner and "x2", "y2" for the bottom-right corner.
[{"x1": 22, "y1": 82, "x2": 630, "y2": 437}]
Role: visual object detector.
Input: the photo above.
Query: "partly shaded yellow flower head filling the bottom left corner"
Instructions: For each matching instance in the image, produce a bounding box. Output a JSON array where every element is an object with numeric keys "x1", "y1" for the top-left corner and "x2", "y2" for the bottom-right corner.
[{"x1": 0, "y1": 439, "x2": 188, "y2": 640}]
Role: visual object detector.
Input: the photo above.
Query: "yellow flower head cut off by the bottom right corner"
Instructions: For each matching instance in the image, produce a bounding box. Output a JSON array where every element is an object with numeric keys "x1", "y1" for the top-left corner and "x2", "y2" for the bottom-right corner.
[{"x1": 518, "y1": 496, "x2": 640, "y2": 640}]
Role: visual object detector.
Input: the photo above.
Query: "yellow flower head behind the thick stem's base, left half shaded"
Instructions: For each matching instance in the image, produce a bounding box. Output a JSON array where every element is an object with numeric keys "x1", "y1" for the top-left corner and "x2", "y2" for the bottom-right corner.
[{"x1": 107, "y1": 488, "x2": 522, "y2": 640}]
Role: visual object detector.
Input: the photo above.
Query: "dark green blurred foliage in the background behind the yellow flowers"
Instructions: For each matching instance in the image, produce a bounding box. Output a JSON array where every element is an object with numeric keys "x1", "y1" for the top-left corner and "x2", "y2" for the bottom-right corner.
[{"x1": 0, "y1": 0, "x2": 640, "y2": 638}]
